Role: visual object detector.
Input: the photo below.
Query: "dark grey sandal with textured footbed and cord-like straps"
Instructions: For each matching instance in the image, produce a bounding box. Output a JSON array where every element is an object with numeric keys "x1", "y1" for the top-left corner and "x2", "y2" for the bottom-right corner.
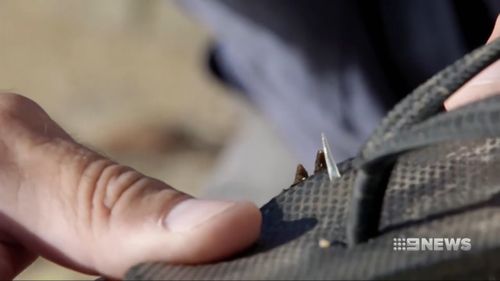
[{"x1": 127, "y1": 37, "x2": 500, "y2": 280}]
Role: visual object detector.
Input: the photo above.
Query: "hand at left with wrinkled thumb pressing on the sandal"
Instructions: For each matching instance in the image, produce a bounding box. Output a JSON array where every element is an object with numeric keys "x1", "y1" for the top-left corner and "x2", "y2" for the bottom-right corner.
[{"x1": 0, "y1": 94, "x2": 261, "y2": 279}]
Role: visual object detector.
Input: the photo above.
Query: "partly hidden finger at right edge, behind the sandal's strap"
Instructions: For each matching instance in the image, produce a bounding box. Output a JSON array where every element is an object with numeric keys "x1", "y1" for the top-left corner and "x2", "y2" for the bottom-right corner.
[{"x1": 444, "y1": 14, "x2": 500, "y2": 110}]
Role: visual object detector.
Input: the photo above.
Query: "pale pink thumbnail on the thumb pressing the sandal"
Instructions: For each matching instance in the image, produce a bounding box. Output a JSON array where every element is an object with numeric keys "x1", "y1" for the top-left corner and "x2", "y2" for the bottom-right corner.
[{"x1": 163, "y1": 199, "x2": 236, "y2": 232}]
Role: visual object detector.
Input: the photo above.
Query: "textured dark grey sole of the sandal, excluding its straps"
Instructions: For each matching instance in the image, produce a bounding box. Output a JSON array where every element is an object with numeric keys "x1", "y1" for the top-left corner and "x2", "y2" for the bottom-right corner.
[{"x1": 127, "y1": 139, "x2": 500, "y2": 280}]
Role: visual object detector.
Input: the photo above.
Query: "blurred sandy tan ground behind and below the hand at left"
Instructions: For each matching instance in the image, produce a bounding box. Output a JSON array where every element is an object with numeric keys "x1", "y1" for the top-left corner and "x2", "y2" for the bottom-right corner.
[{"x1": 0, "y1": 0, "x2": 244, "y2": 279}]
